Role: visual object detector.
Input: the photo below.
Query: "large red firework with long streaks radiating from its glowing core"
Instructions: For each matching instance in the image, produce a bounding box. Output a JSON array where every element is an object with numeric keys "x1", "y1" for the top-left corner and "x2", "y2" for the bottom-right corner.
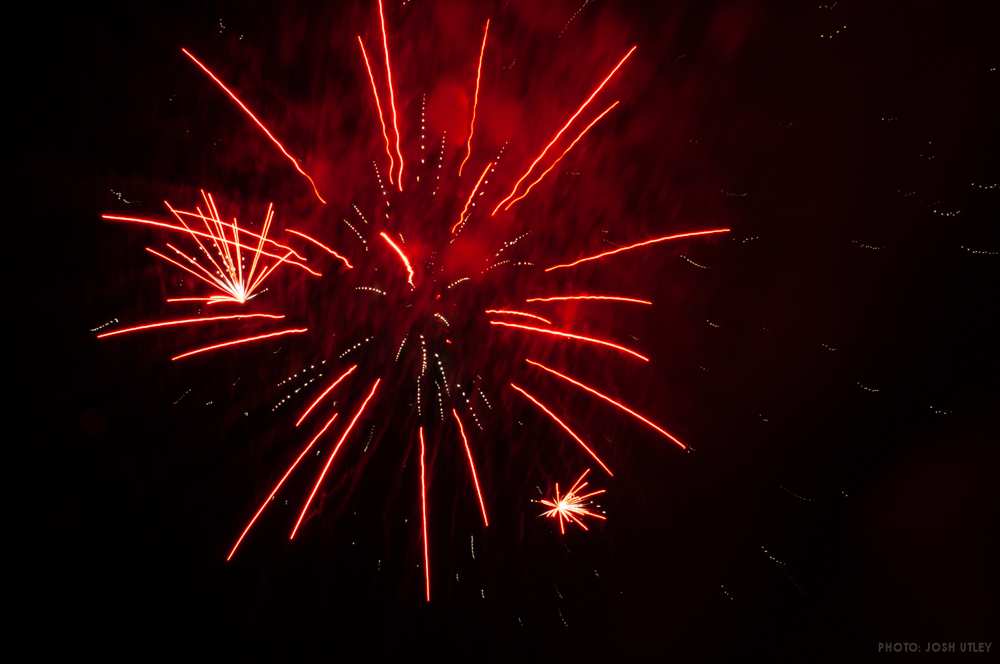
[{"x1": 98, "y1": 1, "x2": 729, "y2": 601}]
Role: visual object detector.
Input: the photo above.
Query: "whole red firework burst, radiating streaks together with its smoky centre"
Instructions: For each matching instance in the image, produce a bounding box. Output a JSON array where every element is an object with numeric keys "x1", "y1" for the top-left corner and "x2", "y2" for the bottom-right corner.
[{"x1": 98, "y1": 1, "x2": 729, "y2": 601}]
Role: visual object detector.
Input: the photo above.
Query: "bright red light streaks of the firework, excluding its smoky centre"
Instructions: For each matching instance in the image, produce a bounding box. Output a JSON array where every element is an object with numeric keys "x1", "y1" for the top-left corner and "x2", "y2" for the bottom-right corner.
[{"x1": 97, "y1": 0, "x2": 729, "y2": 601}]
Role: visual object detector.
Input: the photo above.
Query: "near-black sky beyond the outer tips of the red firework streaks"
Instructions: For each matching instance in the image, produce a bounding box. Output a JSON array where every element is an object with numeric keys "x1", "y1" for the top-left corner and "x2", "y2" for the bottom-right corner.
[{"x1": 27, "y1": 0, "x2": 1000, "y2": 661}]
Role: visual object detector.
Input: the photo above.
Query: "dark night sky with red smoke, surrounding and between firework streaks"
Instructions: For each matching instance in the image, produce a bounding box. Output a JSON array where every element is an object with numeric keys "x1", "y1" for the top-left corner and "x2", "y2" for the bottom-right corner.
[{"x1": 27, "y1": 0, "x2": 1000, "y2": 661}]
